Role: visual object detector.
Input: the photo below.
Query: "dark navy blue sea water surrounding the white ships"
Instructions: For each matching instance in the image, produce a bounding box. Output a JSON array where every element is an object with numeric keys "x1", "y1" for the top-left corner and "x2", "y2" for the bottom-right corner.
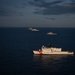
[{"x1": 0, "y1": 28, "x2": 75, "y2": 75}]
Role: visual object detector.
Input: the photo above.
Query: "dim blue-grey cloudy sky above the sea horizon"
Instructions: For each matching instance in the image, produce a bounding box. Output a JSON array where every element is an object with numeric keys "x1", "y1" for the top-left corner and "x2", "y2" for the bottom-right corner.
[{"x1": 0, "y1": 0, "x2": 75, "y2": 27}]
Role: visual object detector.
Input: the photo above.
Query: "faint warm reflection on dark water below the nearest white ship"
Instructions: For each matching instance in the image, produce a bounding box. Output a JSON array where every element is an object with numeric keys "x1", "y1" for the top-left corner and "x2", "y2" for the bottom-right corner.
[{"x1": 34, "y1": 55, "x2": 73, "y2": 73}]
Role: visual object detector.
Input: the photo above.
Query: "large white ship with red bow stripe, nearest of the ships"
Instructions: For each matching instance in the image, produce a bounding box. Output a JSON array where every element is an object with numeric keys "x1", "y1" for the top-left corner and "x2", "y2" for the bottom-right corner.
[{"x1": 33, "y1": 45, "x2": 74, "y2": 55}]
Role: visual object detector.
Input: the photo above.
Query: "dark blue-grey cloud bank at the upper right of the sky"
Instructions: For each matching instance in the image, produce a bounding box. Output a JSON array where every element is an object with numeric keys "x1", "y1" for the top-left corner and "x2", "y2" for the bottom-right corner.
[{"x1": 30, "y1": 0, "x2": 75, "y2": 15}]
